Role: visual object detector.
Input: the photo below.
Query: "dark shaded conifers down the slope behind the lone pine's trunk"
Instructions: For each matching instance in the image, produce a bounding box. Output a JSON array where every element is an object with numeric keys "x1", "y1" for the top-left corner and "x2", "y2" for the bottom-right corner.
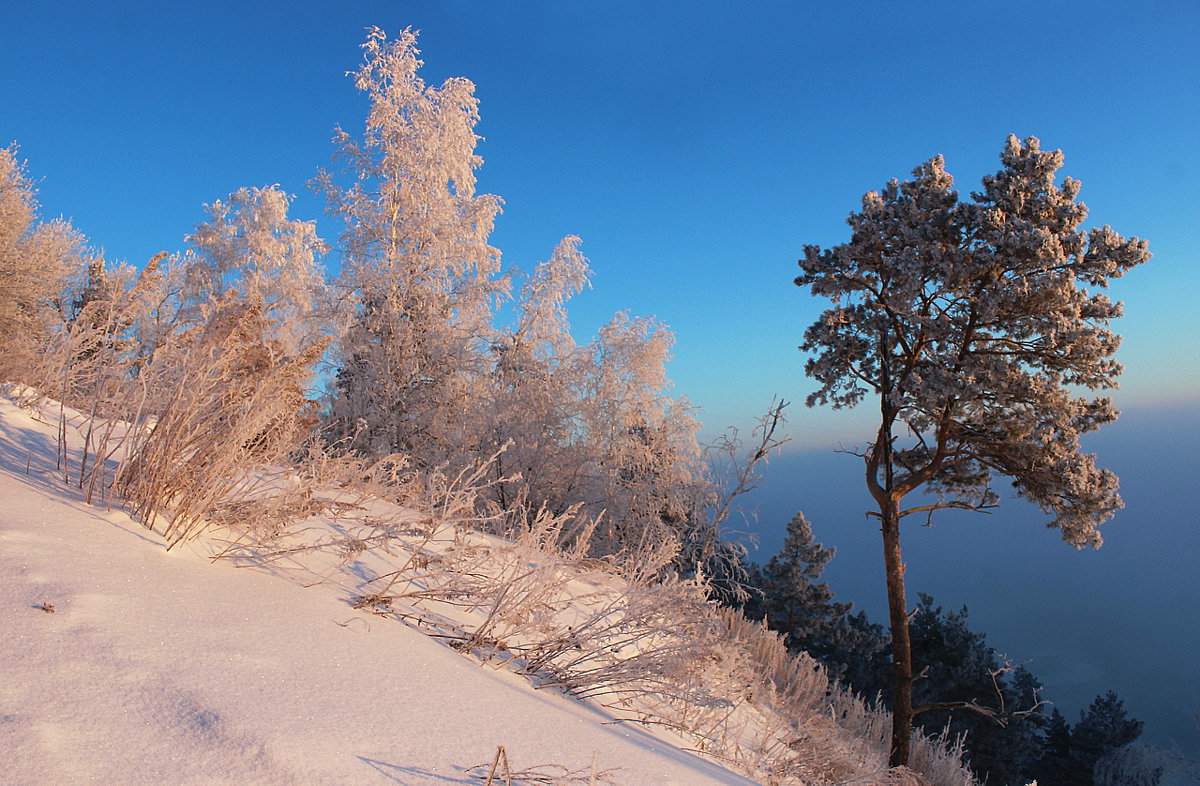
[{"x1": 739, "y1": 514, "x2": 1141, "y2": 786}]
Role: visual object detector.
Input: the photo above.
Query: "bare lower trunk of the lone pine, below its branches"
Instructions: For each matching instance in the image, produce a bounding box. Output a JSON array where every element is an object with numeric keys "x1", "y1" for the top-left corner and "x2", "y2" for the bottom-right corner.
[{"x1": 880, "y1": 499, "x2": 912, "y2": 767}]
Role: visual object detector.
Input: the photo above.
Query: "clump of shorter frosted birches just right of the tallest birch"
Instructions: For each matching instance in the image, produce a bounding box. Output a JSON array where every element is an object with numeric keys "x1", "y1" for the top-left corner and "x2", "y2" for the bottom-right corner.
[{"x1": 473, "y1": 236, "x2": 713, "y2": 559}]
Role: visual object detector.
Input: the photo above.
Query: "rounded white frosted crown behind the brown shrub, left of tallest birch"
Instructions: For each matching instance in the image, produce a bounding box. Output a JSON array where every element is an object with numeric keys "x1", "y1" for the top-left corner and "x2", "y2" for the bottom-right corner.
[{"x1": 185, "y1": 186, "x2": 325, "y2": 352}]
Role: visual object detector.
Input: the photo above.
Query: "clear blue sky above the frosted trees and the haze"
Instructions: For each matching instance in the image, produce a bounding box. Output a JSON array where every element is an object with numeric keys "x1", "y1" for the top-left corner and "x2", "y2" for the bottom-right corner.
[{"x1": 0, "y1": 0, "x2": 1200, "y2": 448}]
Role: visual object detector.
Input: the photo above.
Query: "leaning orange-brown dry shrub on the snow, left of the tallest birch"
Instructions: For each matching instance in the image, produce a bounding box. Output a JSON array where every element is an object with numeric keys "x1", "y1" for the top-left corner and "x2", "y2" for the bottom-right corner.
[{"x1": 116, "y1": 296, "x2": 324, "y2": 545}]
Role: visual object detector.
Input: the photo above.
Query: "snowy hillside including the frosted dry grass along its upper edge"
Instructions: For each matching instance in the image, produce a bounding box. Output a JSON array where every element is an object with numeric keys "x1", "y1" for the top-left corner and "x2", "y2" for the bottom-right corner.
[{"x1": 0, "y1": 397, "x2": 971, "y2": 785}]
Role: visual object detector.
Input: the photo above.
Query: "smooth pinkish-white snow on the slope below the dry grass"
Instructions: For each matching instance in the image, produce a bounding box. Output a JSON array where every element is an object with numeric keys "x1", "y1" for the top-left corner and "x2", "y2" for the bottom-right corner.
[{"x1": 0, "y1": 398, "x2": 750, "y2": 786}]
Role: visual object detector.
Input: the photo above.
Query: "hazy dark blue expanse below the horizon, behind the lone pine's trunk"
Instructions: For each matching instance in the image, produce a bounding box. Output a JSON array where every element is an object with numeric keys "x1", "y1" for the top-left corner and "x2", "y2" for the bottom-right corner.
[{"x1": 748, "y1": 404, "x2": 1200, "y2": 757}]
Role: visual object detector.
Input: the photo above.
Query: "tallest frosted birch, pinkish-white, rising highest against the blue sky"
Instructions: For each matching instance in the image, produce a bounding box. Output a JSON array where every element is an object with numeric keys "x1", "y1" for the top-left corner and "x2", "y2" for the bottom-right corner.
[{"x1": 314, "y1": 28, "x2": 505, "y2": 464}]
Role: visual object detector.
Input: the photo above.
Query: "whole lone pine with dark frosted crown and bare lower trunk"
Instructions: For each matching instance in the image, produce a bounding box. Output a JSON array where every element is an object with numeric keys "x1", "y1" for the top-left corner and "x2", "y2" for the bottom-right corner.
[{"x1": 796, "y1": 137, "x2": 1150, "y2": 764}]
